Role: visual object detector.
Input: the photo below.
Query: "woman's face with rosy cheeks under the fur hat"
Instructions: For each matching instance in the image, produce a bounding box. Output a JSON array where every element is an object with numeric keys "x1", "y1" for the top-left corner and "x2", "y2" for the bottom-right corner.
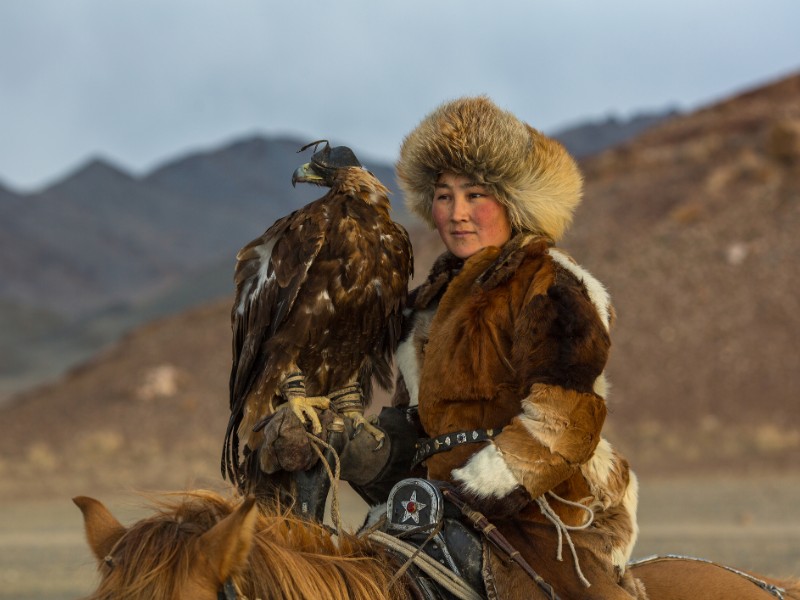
[{"x1": 432, "y1": 172, "x2": 511, "y2": 258}]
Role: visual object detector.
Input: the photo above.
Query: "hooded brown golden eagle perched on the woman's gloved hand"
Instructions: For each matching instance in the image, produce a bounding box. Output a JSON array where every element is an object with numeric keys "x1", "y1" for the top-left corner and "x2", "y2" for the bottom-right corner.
[{"x1": 222, "y1": 140, "x2": 413, "y2": 491}]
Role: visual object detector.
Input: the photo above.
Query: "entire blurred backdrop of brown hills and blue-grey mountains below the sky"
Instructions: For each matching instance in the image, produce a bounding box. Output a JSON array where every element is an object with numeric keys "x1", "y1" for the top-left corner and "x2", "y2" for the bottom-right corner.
[{"x1": 0, "y1": 74, "x2": 800, "y2": 499}]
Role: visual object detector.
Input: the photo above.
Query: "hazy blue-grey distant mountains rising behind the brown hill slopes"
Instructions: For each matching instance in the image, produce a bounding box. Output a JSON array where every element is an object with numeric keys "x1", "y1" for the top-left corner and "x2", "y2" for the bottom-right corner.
[{"x1": 0, "y1": 117, "x2": 668, "y2": 400}]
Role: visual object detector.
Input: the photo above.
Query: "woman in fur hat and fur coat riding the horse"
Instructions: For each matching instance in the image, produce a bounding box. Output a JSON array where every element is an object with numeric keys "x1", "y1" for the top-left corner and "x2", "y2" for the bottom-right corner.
[{"x1": 395, "y1": 97, "x2": 644, "y2": 598}]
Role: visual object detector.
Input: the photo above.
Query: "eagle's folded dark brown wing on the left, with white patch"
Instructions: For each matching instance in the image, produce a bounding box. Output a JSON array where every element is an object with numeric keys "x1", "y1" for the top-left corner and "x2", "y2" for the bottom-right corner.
[{"x1": 223, "y1": 209, "x2": 325, "y2": 481}]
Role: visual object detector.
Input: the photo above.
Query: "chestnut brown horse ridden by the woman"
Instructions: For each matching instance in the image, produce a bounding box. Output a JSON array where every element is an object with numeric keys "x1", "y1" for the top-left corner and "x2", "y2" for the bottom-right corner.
[{"x1": 74, "y1": 491, "x2": 800, "y2": 600}]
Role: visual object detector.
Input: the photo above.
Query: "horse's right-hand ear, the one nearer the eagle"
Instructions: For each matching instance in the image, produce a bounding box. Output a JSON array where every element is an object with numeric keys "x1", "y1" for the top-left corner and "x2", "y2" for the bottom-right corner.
[{"x1": 198, "y1": 496, "x2": 258, "y2": 582}]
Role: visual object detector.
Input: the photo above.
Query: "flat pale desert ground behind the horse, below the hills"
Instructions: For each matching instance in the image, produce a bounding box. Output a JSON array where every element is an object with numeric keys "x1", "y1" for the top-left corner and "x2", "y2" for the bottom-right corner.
[{"x1": 0, "y1": 473, "x2": 800, "y2": 600}]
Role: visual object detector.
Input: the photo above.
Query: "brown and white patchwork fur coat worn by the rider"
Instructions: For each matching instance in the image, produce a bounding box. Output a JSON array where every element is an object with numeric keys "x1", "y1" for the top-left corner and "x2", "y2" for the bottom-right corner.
[{"x1": 395, "y1": 233, "x2": 637, "y2": 598}]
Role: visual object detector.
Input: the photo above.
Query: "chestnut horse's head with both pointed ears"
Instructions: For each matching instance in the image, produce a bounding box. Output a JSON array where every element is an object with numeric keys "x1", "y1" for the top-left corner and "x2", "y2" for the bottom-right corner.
[{"x1": 73, "y1": 496, "x2": 258, "y2": 600}]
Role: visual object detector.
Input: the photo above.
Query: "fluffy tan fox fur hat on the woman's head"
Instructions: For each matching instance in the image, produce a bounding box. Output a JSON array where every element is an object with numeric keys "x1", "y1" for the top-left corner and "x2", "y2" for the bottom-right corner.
[{"x1": 396, "y1": 96, "x2": 583, "y2": 241}]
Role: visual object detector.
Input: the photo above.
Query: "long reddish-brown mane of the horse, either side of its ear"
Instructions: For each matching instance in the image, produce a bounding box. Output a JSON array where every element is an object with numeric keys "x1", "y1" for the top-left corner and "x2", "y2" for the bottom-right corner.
[{"x1": 88, "y1": 490, "x2": 406, "y2": 600}]
